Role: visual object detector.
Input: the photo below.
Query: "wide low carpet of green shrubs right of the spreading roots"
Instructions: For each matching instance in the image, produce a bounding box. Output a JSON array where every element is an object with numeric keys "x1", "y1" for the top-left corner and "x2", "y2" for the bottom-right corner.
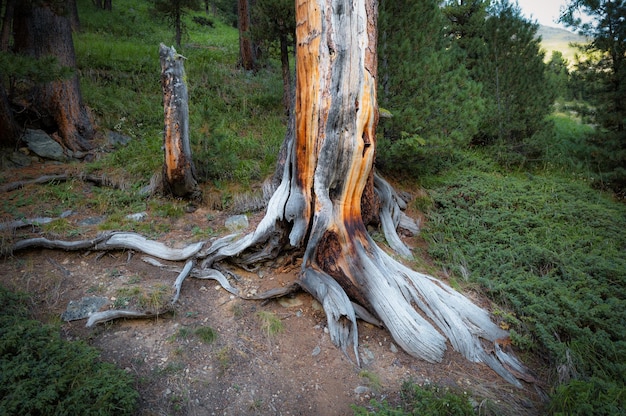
[{"x1": 425, "y1": 154, "x2": 626, "y2": 412}]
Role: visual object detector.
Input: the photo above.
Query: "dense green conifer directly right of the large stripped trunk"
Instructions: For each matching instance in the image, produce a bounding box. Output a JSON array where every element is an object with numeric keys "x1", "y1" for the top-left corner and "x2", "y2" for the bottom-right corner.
[{"x1": 379, "y1": 0, "x2": 482, "y2": 175}]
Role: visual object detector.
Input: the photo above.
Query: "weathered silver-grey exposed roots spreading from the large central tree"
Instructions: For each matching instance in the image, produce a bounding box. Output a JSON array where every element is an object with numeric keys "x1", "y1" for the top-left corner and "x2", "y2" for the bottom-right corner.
[{"x1": 7, "y1": 177, "x2": 529, "y2": 386}]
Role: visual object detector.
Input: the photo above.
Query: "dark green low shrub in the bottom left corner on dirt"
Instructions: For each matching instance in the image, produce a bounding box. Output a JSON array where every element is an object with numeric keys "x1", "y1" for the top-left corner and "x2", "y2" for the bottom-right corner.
[{"x1": 0, "y1": 287, "x2": 139, "y2": 415}]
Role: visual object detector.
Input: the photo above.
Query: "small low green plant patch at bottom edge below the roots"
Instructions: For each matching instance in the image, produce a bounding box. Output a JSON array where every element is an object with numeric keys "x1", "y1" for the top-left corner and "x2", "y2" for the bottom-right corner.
[{"x1": 353, "y1": 380, "x2": 475, "y2": 416}]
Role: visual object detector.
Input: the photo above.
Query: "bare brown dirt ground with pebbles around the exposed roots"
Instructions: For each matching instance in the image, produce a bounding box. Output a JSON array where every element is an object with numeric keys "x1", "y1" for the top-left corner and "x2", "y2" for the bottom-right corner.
[{"x1": 0, "y1": 160, "x2": 543, "y2": 415}]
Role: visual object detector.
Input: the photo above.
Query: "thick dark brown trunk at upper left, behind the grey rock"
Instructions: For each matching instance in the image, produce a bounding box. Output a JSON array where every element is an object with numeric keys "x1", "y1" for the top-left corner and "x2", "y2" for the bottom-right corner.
[{"x1": 14, "y1": 2, "x2": 94, "y2": 151}]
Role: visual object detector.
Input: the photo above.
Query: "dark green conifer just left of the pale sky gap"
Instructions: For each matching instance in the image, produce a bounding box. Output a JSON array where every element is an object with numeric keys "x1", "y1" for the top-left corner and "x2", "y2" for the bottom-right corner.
[{"x1": 473, "y1": 0, "x2": 554, "y2": 146}]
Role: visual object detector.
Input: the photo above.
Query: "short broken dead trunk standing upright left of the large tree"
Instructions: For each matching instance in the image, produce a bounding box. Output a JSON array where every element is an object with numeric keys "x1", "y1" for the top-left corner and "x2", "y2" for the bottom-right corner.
[{"x1": 159, "y1": 44, "x2": 201, "y2": 199}]
